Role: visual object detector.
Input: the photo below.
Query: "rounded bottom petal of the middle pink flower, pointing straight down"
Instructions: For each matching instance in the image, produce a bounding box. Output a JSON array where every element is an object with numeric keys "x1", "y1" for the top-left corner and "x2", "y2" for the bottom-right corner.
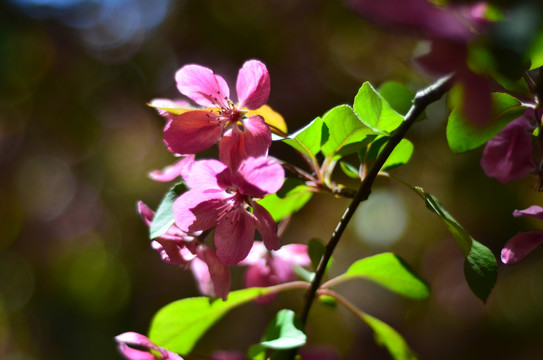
[{"x1": 215, "y1": 208, "x2": 255, "y2": 265}]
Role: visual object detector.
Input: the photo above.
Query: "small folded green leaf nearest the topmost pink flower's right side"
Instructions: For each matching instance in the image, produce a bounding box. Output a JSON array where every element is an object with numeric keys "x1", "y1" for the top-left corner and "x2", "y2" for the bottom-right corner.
[{"x1": 283, "y1": 117, "x2": 328, "y2": 156}]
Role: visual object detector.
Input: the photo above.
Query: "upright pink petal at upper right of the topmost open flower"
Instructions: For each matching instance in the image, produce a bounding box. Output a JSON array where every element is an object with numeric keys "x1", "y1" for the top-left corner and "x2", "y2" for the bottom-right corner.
[{"x1": 236, "y1": 60, "x2": 270, "y2": 110}]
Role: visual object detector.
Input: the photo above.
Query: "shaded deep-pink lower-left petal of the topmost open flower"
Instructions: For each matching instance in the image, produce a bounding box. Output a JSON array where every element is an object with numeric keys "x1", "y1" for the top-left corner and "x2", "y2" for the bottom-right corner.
[{"x1": 164, "y1": 110, "x2": 223, "y2": 155}]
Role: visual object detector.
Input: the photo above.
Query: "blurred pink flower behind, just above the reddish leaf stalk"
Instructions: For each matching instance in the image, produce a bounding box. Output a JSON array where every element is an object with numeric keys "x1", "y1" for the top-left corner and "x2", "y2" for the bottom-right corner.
[{"x1": 240, "y1": 241, "x2": 311, "y2": 303}]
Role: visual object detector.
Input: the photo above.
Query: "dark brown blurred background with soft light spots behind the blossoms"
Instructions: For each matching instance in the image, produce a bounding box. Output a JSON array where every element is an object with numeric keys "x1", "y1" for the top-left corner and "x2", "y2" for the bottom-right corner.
[{"x1": 0, "y1": 0, "x2": 543, "y2": 360}]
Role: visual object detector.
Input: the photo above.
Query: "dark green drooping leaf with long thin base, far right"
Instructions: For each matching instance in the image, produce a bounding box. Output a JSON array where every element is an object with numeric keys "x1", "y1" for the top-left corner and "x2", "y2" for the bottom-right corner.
[{"x1": 414, "y1": 188, "x2": 498, "y2": 302}]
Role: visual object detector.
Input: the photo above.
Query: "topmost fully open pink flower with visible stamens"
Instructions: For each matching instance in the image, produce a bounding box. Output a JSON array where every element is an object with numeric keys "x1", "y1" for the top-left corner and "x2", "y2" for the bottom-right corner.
[{"x1": 164, "y1": 60, "x2": 271, "y2": 167}]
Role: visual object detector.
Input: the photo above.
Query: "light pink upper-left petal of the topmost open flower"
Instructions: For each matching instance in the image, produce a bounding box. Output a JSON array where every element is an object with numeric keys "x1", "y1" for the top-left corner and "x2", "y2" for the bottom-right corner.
[{"x1": 175, "y1": 65, "x2": 230, "y2": 108}]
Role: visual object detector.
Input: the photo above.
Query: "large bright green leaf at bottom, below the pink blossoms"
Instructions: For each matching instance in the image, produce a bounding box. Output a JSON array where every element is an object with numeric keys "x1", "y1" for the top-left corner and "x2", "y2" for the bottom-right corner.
[{"x1": 149, "y1": 288, "x2": 270, "y2": 355}]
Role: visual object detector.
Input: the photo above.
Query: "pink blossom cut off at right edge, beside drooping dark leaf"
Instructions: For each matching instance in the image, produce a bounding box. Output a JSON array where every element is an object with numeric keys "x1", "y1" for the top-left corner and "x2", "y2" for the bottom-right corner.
[{"x1": 501, "y1": 205, "x2": 543, "y2": 265}]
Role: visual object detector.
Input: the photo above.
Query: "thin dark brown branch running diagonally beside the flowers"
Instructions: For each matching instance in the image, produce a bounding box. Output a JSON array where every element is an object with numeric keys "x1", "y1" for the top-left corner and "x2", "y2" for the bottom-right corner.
[{"x1": 300, "y1": 74, "x2": 453, "y2": 326}]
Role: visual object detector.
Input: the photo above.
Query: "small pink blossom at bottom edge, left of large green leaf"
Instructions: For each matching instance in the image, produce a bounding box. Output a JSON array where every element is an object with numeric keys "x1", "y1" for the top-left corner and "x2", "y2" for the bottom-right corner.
[{"x1": 115, "y1": 332, "x2": 183, "y2": 360}]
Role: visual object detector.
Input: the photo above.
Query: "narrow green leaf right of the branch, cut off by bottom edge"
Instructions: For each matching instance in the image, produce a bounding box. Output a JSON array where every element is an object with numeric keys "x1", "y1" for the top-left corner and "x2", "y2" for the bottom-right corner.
[{"x1": 358, "y1": 312, "x2": 417, "y2": 360}]
